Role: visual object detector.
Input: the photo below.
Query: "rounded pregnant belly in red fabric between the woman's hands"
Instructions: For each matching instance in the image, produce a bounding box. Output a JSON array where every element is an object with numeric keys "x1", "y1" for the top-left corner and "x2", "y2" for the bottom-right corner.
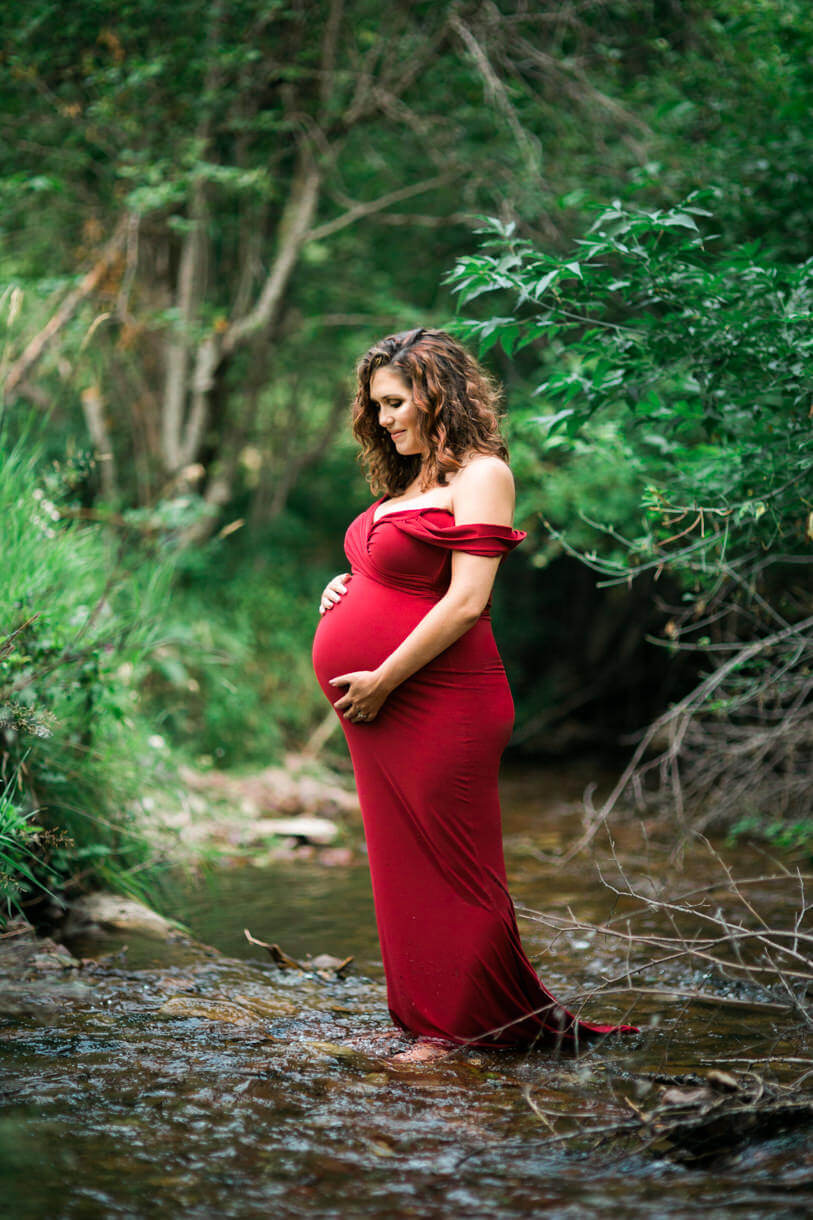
[{"x1": 313, "y1": 572, "x2": 436, "y2": 702}]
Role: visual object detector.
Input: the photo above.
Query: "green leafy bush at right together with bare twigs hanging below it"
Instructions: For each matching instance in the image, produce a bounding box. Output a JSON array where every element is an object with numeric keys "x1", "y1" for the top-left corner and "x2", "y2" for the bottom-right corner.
[{"x1": 448, "y1": 197, "x2": 813, "y2": 825}]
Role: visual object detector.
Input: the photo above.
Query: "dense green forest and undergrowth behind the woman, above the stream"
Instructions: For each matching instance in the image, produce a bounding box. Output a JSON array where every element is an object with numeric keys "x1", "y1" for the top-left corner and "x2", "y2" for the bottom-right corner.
[{"x1": 0, "y1": 0, "x2": 813, "y2": 909}]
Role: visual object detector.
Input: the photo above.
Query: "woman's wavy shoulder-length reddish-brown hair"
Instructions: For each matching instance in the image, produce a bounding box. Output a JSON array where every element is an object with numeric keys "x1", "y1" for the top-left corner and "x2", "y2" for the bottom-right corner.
[{"x1": 353, "y1": 327, "x2": 508, "y2": 495}]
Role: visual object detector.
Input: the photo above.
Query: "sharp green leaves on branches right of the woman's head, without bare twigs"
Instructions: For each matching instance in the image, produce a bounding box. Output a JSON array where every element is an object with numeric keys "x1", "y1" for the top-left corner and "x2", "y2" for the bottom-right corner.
[{"x1": 448, "y1": 192, "x2": 813, "y2": 580}]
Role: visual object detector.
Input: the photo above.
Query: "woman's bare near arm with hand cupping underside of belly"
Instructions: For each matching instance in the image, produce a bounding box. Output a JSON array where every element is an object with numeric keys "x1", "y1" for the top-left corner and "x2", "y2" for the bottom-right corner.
[{"x1": 331, "y1": 458, "x2": 514, "y2": 720}]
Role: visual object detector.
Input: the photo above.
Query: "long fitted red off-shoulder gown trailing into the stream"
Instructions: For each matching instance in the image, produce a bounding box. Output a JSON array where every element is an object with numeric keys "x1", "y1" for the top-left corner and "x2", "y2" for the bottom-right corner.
[{"x1": 313, "y1": 497, "x2": 634, "y2": 1047}]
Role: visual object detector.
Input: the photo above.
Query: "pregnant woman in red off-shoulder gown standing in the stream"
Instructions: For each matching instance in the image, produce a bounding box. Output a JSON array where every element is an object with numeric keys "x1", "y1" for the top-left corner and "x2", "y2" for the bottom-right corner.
[{"x1": 314, "y1": 328, "x2": 634, "y2": 1061}]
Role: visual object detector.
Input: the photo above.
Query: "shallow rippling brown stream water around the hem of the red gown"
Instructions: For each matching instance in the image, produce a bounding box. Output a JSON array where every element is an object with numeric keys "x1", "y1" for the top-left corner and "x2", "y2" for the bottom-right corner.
[{"x1": 0, "y1": 773, "x2": 813, "y2": 1220}]
